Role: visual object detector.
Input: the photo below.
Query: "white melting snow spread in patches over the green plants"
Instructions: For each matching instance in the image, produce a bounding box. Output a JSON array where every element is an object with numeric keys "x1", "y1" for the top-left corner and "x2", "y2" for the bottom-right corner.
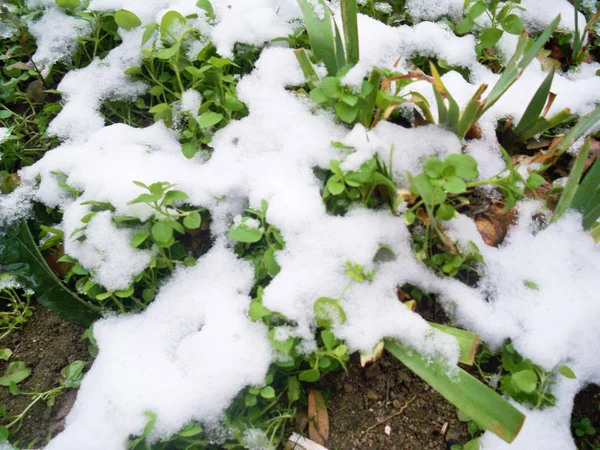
[{"x1": 0, "y1": 0, "x2": 600, "y2": 450}]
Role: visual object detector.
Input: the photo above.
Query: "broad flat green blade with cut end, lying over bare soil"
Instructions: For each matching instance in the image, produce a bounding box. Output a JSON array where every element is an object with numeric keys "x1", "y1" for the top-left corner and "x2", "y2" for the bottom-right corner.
[{"x1": 385, "y1": 339, "x2": 525, "y2": 443}]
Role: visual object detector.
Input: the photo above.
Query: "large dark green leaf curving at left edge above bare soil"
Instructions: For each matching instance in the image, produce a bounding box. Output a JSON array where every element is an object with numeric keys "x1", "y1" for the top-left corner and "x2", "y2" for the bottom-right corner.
[{"x1": 0, "y1": 221, "x2": 100, "y2": 327}]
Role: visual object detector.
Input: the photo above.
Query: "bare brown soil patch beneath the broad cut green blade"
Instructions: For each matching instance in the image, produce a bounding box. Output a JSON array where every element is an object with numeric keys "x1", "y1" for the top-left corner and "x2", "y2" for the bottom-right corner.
[{"x1": 324, "y1": 354, "x2": 470, "y2": 450}]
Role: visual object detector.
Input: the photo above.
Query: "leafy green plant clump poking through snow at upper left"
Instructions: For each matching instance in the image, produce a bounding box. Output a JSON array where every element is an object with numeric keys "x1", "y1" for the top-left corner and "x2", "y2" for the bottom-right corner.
[{"x1": 122, "y1": 7, "x2": 251, "y2": 158}]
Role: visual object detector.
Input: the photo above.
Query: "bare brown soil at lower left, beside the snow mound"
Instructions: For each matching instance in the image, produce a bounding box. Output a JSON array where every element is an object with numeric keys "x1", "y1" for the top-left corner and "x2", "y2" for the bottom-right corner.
[{"x1": 0, "y1": 305, "x2": 91, "y2": 448}]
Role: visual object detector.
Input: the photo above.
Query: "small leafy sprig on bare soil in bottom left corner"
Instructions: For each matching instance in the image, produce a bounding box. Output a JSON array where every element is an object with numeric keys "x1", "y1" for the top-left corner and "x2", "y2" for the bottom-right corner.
[{"x1": 0, "y1": 361, "x2": 86, "y2": 442}]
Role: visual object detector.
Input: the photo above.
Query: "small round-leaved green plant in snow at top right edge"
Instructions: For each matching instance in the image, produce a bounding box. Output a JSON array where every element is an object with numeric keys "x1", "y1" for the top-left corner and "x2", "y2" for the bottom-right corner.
[{"x1": 454, "y1": 0, "x2": 524, "y2": 55}]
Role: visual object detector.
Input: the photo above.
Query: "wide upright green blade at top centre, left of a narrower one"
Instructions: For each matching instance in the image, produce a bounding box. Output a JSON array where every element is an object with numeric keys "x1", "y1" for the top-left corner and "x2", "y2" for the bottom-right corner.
[{"x1": 298, "y1": 0, "x2": 339, "y2": 75}]
